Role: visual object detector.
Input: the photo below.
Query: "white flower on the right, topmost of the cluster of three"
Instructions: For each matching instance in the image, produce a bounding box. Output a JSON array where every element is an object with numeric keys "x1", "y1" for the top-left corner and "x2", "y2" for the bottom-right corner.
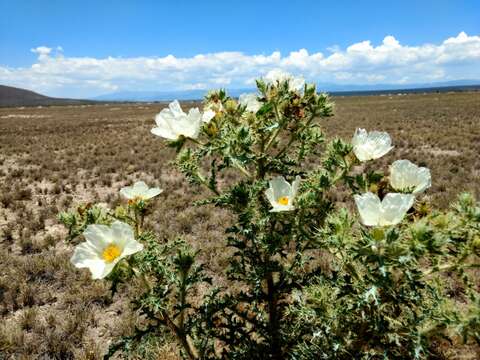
[{"x1": 352, "y1": 129, "x2": 393, "y2": 161}]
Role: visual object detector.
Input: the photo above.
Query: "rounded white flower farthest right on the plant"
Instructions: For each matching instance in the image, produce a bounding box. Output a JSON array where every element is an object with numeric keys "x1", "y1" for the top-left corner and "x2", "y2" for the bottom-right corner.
[{"x1": 390, "y1": 160, "x2": 432, "y2": 194}]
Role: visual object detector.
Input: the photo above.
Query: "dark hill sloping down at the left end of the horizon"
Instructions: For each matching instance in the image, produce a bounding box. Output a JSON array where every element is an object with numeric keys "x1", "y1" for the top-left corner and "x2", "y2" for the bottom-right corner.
[{"x1": 0, "y1": 85, "x2": 93, "y2": 107}]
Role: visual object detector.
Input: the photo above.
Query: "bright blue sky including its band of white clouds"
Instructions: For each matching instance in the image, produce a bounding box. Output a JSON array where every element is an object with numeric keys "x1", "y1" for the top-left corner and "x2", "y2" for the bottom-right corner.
[{"x1": 0, "y1": 0, "x2": 480, "y2": 96}]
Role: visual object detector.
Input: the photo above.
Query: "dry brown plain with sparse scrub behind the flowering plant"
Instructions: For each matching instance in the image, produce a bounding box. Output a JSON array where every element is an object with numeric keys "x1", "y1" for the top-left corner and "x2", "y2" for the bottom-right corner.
[{"x1": 0, "y1": 92, "x2": 480, "y2": 359}]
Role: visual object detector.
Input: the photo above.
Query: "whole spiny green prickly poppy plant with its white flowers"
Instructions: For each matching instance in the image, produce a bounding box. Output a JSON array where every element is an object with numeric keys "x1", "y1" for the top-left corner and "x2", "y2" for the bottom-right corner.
[{"x1": 60, "y1": 71, "x2": 480, "y2": 360}]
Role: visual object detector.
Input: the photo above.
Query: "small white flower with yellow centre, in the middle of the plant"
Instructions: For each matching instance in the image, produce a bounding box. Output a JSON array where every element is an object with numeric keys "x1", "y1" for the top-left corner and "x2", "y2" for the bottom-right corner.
[{"x1": 265, "y1": 176, "x2": 300, "y2": 212}]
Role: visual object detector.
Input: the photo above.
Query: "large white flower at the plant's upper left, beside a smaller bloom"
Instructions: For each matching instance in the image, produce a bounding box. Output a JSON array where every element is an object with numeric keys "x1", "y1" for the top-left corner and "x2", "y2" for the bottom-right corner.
[{"x1": 151, "y1": 100, "x2": 215, "y2": 140}]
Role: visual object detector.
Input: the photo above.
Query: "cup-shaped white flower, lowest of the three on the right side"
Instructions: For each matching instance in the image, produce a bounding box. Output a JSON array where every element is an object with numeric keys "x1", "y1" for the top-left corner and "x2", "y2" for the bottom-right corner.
[{"x1": 354, "y1": 192, "x2": 415, "y2": 226}]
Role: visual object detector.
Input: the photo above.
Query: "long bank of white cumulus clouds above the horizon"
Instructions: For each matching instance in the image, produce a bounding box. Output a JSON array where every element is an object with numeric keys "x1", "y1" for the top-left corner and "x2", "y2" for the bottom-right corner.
[{"x1": 0, "y1": 32, "x2": 480, "y2": 97}]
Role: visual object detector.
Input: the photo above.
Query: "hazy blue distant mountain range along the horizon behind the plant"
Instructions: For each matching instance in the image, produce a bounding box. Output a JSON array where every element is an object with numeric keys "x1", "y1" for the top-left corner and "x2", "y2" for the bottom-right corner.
[{"x1": 92, "y1": 80, "x2": 480, "y2": 101}]
